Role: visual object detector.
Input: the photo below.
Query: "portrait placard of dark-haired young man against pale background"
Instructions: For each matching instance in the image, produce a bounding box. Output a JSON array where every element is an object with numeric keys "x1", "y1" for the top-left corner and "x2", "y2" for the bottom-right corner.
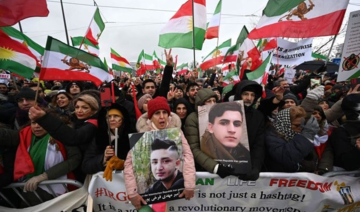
[{"x1": 198, "y1": 100, "x2": 251, "y2": 174}]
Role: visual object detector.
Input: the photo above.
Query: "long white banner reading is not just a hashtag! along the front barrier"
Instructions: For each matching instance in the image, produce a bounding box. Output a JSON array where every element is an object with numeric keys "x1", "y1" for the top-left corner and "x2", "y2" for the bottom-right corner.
[{"x1": 89, "y1": 172, "x2": 360, "y2": 212}]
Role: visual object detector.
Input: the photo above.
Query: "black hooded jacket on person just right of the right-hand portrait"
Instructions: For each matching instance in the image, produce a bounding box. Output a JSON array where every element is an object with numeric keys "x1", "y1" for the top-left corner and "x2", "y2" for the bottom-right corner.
[{"x1": 234, "y1": 80, "x2": 265, "y2": 180}]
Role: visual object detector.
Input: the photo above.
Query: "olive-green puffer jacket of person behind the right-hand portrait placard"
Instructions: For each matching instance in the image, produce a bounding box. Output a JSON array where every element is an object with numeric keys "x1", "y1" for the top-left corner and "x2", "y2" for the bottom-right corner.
[{"x1": 184, "y1": 88, "x2": 218, "y2": 173}]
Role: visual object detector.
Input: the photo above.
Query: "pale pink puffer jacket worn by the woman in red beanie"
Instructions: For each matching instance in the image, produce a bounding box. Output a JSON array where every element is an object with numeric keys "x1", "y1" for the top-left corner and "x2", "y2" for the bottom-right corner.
[{"x1": 124, "y1": 113, "x2": 196, "y2": 198}]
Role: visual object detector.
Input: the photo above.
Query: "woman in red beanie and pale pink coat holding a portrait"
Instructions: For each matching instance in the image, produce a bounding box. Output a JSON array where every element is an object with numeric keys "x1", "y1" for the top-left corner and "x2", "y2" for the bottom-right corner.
[{"x1": 124, "y1": 97, "x2": 196, "y2": 210}]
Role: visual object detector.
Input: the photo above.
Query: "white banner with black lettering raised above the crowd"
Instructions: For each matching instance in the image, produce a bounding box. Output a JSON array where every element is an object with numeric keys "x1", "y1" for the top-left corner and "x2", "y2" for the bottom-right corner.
[{"x1": 268, "y1": 38, "x2": 313, "y2": 66}]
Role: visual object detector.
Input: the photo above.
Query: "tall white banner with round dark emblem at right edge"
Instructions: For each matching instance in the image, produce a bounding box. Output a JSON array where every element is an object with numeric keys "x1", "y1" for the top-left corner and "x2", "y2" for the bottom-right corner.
[{"x1": 337, "y1": 10, "x2": 360, "y2": 82}]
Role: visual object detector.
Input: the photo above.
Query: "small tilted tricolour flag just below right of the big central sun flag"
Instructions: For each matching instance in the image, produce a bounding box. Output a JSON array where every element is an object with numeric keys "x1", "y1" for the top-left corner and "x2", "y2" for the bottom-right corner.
[{"x1": 200, "y1": 39, "x2": 231, "y2": 70}]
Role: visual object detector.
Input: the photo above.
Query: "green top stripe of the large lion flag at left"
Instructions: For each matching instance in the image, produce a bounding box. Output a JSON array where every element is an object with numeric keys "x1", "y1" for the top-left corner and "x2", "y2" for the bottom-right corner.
[{"x1": 46, "y1": 36, "x2": 108, "y2": 72}]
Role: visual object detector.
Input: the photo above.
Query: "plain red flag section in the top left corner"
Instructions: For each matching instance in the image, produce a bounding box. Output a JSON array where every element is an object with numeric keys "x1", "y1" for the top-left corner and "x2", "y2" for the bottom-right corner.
[{"x1": 0, "y1": 0, "x2": 49, "y2": 27}]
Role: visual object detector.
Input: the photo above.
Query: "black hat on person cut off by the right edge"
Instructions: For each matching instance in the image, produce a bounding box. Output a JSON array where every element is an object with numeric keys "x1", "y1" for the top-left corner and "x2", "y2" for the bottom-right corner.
[{"x1": 341, "y1": 94, "x2": 360, "y2": 121}]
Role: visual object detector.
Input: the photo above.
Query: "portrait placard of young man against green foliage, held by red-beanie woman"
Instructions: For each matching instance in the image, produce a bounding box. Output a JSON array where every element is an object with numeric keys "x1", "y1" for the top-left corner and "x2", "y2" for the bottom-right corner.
[{"x1": 129, "y1": 128, "x2": 184, "y2": 204}]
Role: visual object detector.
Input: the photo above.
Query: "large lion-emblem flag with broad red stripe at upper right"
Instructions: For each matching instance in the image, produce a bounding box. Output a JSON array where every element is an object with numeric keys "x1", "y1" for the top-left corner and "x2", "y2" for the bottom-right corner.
[{"x1": 249, "y1": 0, "x2": 349, "y2": 39}]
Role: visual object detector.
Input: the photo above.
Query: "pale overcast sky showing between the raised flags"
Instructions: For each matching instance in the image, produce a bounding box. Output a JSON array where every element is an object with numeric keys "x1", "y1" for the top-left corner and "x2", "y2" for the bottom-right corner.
[{"x1": 14, "y1": 0, "x2": 360, "y2": 64}]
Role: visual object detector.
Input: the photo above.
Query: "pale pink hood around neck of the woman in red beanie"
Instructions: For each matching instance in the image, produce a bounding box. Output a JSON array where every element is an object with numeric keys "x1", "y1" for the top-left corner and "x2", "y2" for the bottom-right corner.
[{"x1": 136, "y1": 112, "x2": 181, "y2": 132}]
